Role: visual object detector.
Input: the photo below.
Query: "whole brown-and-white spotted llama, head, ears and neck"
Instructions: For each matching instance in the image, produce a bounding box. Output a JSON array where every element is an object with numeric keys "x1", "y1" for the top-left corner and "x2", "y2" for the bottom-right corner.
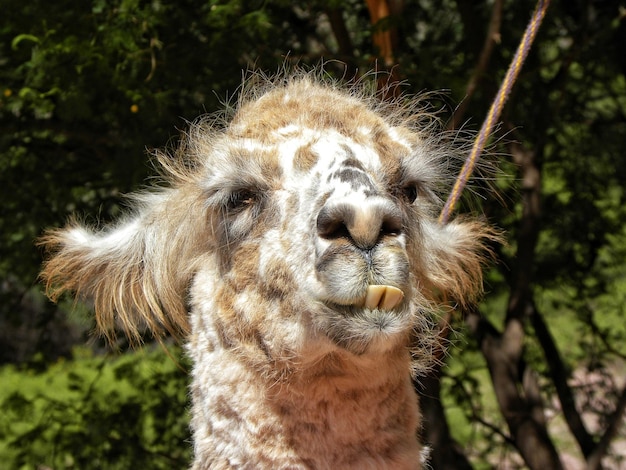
[{"x1": 42, "y1": 71, "x2": 491, "y2": 470}]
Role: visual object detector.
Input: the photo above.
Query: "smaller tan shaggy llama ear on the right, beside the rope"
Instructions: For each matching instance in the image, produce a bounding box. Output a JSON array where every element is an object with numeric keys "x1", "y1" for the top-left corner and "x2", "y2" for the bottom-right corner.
[{"x1": 424, "y1": 218, "x2": 501, "y2": 307}]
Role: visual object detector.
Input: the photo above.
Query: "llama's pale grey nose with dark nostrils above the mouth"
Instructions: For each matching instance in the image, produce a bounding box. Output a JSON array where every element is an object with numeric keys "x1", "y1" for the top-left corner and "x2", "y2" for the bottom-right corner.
[{"x1": 317, "y1": 197, "x2": 402, "y2": 250}]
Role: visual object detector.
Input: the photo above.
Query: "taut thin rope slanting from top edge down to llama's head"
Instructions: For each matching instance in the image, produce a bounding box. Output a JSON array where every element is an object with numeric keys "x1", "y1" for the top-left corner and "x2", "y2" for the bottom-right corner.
[{"x1": 439, "y1": 0, "x2": 550, "y2": 224}]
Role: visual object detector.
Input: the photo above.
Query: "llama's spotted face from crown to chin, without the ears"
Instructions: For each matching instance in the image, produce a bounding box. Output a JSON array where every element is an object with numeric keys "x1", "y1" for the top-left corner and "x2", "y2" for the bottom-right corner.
[{"x1": 192, "y1": 82, "x2": 448, "y2": 354}]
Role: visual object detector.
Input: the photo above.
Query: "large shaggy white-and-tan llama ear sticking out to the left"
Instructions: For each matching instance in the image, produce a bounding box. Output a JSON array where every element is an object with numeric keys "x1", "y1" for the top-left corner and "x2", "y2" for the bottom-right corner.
[{"x1": 39, "y1": 190, "x2": 201, "y2": 343}]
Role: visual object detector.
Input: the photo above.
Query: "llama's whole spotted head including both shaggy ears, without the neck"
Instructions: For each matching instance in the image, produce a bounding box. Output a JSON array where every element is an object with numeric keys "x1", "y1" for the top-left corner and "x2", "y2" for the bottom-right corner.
[{"x1": 43, "y1": 70, "x2": 490, "y2": 367}]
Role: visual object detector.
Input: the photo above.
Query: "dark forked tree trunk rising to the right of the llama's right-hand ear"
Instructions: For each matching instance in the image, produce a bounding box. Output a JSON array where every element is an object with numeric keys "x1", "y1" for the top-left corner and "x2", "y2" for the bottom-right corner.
[{"x1": 460, "y1": 129, "x2": 562, "y2": 469}]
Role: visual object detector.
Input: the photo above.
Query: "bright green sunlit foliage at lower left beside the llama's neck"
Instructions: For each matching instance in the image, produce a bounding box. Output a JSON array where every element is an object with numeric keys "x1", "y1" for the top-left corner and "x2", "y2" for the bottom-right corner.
[{"x1": 0, "y1": 349, "x2": 191, "y2": 470}]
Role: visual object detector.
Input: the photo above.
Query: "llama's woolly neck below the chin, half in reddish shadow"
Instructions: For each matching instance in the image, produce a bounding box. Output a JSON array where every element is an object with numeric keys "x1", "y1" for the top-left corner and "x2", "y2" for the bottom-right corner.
[{"x1": 189, "y1": 336, "x2": 420, "y2": 469}]
